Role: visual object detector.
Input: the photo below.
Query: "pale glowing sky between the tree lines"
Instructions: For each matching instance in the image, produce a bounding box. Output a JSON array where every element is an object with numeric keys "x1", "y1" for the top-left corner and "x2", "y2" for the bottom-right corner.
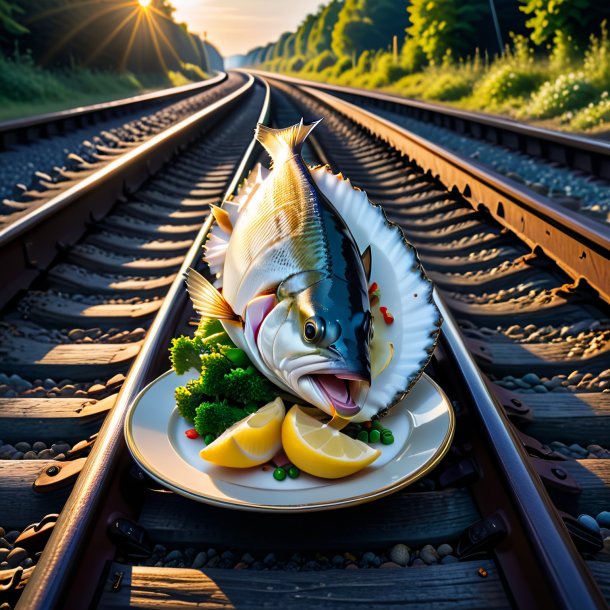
[{"x1": 171, "y1": 0, "x2": 322, "y2": 57}]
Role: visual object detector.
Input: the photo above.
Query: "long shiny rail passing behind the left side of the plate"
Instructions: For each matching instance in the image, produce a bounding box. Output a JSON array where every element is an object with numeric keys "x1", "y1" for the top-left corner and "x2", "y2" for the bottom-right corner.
[{"x1": 17, "y1": 79, "x2": 270, "y2": 610}]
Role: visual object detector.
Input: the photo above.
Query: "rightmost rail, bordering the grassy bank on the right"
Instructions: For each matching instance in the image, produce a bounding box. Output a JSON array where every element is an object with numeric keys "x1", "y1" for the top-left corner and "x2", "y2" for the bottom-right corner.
[{"x1": 243, "y1": 68, "x2": 610, "y2": 179}]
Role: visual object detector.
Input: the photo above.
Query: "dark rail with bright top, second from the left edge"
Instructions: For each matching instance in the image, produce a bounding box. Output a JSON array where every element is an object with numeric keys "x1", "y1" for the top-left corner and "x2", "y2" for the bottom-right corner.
[{"x1": 0, "y1": 76, "x2": 249, "y2": 306}]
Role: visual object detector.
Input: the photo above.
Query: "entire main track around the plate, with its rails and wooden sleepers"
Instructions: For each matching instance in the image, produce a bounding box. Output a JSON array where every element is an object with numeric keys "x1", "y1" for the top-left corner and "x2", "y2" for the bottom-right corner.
[{"x1": 0, "y1": 74, "x2": 610, "y2": 609}]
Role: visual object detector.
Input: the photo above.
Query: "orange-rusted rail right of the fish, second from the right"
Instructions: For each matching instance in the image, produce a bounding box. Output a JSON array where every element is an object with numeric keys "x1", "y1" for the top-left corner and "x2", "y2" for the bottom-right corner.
[{"x1": 282, "y1": 78, "x2": 610, "y2": 302}]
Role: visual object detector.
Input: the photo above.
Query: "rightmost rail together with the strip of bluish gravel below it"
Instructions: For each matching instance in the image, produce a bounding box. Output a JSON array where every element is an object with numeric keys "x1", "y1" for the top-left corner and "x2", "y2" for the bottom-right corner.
[{"x1": 252, "y1": 70, "x2": 610, "y2": 225}]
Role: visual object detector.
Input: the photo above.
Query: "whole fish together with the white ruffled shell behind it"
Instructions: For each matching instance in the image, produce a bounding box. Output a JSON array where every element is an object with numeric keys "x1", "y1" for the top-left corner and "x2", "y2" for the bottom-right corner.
[{"x1": 187, "y1": 119, "x2": 442, "y2": 421}]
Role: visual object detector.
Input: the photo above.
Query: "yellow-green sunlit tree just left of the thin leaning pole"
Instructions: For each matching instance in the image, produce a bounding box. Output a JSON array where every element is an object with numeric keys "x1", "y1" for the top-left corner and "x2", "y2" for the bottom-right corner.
[{"x1": 407, "y1": 0, "x2": 489, "y2": 63}]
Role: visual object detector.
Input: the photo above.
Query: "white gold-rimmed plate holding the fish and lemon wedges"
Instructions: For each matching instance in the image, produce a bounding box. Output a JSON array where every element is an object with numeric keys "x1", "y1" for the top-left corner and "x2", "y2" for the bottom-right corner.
[{"x1": 125, "y1": 371, "x2": 455, "y2": 512}]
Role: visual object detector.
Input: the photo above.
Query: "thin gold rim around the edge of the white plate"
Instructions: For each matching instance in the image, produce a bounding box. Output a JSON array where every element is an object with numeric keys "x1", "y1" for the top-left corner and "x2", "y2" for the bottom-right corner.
[{"x1": 124, "y1": 369, "x2": 455, "y2": 513}]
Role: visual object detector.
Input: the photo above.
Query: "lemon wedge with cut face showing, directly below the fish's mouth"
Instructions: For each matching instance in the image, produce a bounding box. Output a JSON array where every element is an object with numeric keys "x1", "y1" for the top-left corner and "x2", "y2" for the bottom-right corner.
[{"x1": 282, "y1": 405, "x2": 381, "y2": 479}]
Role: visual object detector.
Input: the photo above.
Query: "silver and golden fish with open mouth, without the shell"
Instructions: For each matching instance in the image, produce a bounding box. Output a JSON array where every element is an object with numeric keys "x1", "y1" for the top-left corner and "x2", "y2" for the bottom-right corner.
[{"x1": 187, "y1": 119, "x2": 372, "y2": 419}]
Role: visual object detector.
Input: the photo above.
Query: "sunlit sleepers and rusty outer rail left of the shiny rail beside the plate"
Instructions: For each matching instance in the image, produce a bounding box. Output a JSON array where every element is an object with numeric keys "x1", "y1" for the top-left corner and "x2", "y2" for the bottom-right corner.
[{"x1": 0, "y1": 70, "x2": 265, "y2": 600}]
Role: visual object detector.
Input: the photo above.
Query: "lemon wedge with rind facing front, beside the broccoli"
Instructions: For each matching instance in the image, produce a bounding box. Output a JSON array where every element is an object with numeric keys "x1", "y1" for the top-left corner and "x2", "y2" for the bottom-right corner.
[{"x1": 199, "y1": 397, "x2": 286, "y2": 468}]
